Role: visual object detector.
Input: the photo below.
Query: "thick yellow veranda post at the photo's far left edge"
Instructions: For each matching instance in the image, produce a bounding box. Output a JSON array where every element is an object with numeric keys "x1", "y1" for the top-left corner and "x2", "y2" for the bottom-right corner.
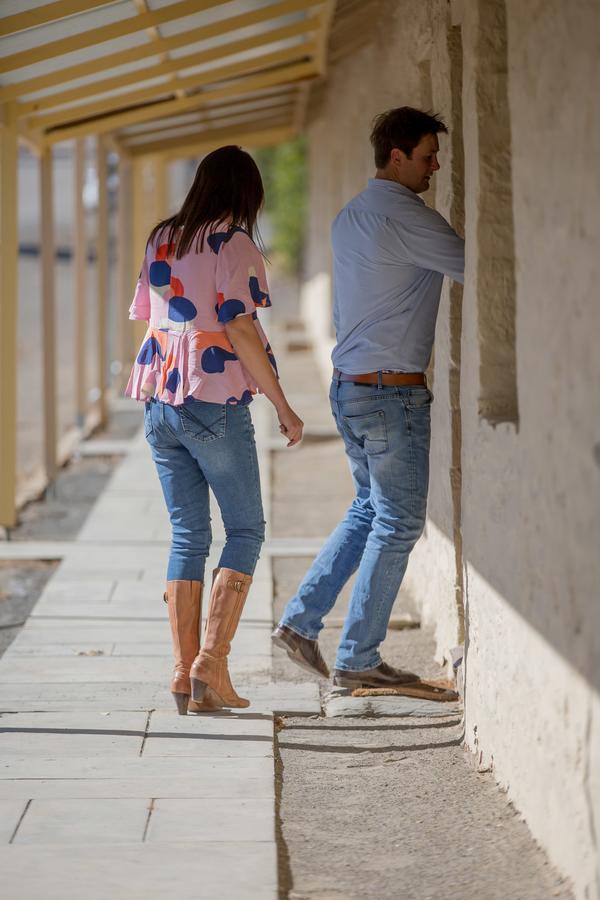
[{"x1": 0, "y1": 104, "x2": 19, "y2": 527}]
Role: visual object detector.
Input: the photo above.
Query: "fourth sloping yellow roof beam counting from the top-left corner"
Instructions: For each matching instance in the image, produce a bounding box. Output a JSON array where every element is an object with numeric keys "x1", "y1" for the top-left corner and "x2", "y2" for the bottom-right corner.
[{"x1": 18, "y1": 16, "x2": 321, "y2": 116}]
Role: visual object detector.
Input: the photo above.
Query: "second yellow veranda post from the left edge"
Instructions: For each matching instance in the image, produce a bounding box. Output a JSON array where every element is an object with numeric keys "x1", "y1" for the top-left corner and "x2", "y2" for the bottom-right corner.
[{"x1": 40, "y1": 148, "x2": 56, "y2": 482}]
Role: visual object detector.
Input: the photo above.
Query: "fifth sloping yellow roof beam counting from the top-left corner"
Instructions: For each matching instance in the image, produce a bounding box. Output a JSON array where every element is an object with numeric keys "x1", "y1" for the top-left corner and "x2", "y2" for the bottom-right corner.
[{"x1": 27, "y1": 41, "x2": 316, "y2": 129}]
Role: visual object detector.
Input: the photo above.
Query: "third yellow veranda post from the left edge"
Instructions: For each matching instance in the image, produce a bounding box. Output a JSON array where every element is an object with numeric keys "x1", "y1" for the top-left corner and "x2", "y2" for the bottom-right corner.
[{"x1": 73, "y1": 138, "x2": 88, "y2": 428}]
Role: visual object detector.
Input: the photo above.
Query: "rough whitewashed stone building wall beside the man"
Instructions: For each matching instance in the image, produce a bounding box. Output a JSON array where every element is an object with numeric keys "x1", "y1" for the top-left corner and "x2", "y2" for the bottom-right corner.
[{"x1": 302, "y1": 0, "x2": 600, "y2": 900}]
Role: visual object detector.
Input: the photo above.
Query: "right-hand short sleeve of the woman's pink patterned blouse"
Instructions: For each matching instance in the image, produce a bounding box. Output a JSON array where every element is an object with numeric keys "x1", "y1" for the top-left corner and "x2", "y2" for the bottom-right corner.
[{"x1": 216, "y1": 231, "x2": 271, "y2": 324}]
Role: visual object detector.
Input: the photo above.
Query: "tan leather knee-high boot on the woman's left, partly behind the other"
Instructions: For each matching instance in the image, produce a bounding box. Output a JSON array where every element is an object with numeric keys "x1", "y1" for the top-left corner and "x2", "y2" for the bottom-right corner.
[{"x1": 164, "y1": 581, "x2": 214, "y2": 716}]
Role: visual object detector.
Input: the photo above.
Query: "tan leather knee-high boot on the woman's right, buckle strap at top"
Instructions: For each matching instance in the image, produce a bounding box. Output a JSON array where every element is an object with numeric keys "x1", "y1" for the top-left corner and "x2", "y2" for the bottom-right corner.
[{"x1": 190, "y1": 569, "x2": 252, "y2": 708}]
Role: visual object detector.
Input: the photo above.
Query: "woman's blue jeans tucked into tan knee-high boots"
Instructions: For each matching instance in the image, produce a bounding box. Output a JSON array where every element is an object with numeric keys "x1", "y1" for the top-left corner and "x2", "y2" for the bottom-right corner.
[{"x1": 144, "y1": 400, "x2": 265, "y2": 581}]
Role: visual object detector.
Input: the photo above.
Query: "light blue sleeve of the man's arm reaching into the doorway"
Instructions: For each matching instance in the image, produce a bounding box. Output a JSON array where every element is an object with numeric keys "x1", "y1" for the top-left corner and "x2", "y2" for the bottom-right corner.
[{"x1": 401, "y1": 206, "x2": 465, "y2": 284}]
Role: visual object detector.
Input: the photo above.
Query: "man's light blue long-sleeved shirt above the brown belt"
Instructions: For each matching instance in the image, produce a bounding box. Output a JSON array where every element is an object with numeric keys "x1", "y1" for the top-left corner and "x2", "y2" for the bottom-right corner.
[{"x1": 331, "y1": 178, "x2": 465, "y2": 375}]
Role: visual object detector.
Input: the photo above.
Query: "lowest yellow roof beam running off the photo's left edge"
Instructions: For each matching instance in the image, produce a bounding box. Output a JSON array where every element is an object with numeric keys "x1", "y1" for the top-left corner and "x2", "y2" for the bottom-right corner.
[{"x1": 0, "y1": 0, "x2": 316, "y2": 101}]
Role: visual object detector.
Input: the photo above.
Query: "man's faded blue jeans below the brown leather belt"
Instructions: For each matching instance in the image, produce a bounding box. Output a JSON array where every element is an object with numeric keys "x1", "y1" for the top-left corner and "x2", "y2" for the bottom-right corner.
[{"x1": 281, "y1": 378, "x2": 433, "y2": 671}]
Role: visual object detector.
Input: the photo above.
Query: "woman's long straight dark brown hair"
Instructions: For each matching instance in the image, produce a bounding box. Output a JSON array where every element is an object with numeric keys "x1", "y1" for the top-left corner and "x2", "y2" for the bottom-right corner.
[{"x1": 148, "y1": 145, "x2": 264, "y2": 259}]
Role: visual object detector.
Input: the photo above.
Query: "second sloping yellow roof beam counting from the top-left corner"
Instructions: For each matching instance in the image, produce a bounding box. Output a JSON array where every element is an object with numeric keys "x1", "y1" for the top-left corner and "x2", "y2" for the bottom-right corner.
[{"x1": 0, "y1": 0, "x2": 229, "y2": 72}]
